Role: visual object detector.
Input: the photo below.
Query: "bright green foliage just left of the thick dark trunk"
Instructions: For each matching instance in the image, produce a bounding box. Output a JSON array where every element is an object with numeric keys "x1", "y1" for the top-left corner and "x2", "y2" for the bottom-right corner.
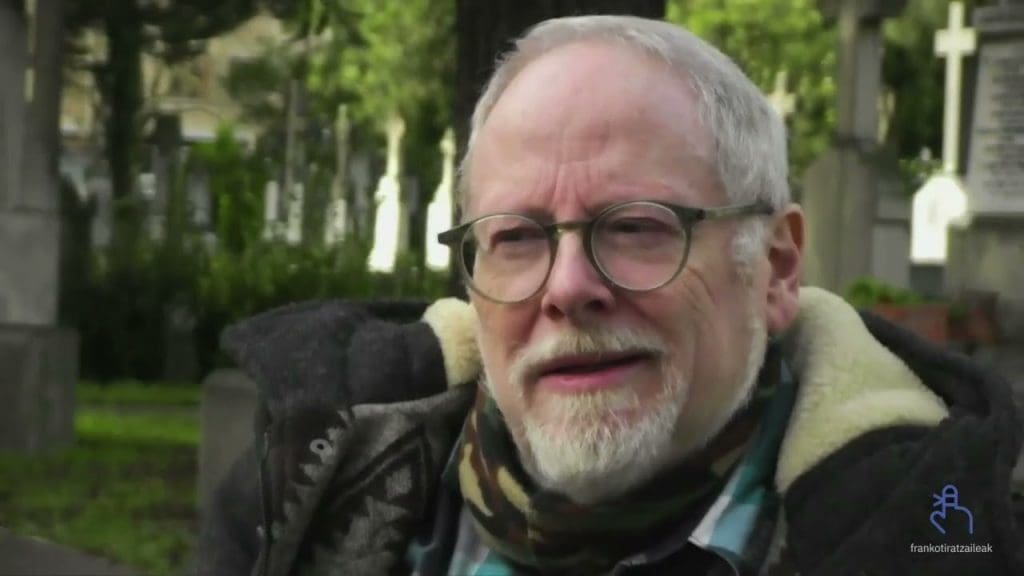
[{"x1": 226, "y1": 0, "x2": 455, "y2": 238}]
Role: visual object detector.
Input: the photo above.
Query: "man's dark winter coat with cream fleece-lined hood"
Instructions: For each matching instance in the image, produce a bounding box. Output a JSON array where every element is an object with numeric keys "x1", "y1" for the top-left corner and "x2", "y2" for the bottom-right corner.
[{"x1": 196, "y1": 288, "x2": 1024, "y2": 576}]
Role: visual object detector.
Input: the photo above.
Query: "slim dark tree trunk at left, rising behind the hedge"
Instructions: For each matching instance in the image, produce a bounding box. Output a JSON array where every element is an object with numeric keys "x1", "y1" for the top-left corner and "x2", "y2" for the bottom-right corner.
[{"x1": 105, "y1": 0, "x2": 143, "y2": 255}]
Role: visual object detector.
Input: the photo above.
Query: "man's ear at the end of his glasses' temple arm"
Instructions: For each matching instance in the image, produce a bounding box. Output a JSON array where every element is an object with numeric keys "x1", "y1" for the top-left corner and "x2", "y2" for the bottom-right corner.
[{"x1": 766, "y1": 204, "x2": 804, "y2": 334}]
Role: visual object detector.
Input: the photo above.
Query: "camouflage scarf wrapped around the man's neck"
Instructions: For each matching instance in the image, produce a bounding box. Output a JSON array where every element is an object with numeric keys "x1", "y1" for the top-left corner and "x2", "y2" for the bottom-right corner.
[{"x1": 459, "y1": 375, "x2": 771, "y2": 574}]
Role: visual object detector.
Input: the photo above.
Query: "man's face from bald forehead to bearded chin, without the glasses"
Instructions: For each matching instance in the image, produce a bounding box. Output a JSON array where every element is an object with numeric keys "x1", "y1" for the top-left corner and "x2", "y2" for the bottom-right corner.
[{"x1": 467, "y1": 43, "x2": 767, "y2": 501}]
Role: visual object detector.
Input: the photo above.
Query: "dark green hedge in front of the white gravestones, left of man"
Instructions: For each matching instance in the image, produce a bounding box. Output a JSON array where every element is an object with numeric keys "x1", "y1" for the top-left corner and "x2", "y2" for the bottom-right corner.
[{"x1": 76, "y1": 238, "x2": 447, "y2": 381}]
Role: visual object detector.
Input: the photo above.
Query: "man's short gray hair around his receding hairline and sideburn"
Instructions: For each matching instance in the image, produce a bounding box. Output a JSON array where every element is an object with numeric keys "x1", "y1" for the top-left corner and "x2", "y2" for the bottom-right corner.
[{"x1": 458, "y1": 15, "x2": 790, "y2": 272}]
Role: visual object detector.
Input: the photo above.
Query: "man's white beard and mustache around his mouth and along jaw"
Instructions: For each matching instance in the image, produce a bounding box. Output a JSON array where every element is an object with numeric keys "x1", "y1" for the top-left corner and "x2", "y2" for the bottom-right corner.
[{"x1": 484, "y1": 307, "x2": 767, "y2": 504}]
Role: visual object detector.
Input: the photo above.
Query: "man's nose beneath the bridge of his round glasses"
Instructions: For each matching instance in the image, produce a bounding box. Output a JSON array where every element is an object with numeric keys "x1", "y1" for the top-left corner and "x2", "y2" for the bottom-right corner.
[{"x1": 541, "y1": 234, "x2": 614, "y2": 322}]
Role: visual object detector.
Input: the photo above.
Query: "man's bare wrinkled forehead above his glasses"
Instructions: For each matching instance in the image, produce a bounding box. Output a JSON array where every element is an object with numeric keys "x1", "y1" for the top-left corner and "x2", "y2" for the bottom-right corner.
[{"x1": 466, "y1": 41, "x2": 714, "y2": 212}]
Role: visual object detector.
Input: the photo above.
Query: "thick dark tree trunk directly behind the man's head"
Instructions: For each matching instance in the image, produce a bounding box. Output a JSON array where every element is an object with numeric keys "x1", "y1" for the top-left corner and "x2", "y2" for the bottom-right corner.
[{"x1": 450, "y1": 0, "x2": 666, "y2": 296}]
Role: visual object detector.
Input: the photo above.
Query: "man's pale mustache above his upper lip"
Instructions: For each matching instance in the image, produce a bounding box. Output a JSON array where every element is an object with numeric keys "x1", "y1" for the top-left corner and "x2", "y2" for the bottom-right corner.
[{"x1": 509, "y1": 327, "x2": 668, "y2": 387}]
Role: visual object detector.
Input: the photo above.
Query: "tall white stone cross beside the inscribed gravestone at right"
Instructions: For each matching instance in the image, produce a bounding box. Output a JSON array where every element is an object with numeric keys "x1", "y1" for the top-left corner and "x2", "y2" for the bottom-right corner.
[{"x1": 935, "y1": 2, "x2": 978, "y2": 174}]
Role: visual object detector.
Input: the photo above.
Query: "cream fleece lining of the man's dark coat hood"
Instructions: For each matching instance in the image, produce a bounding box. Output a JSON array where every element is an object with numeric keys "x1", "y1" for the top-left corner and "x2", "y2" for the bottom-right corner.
[{"x1": 423, "y1": 287, "x2": 948, "y2": 493}]
